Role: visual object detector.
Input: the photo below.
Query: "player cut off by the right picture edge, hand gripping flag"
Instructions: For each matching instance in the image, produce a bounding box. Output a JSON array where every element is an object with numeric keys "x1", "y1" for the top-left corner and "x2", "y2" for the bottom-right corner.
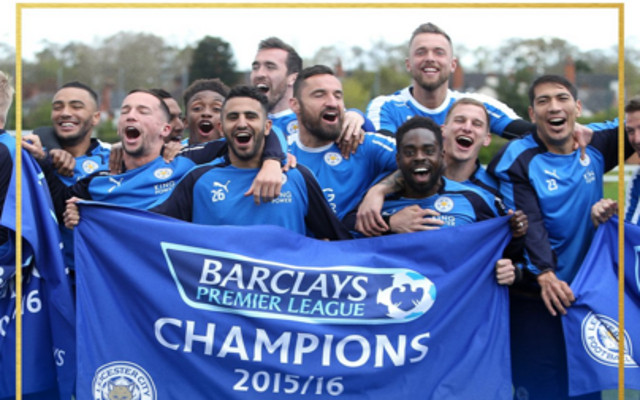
[{"x1": 591, "y1": 97, "x2": 640, "y2": 226}]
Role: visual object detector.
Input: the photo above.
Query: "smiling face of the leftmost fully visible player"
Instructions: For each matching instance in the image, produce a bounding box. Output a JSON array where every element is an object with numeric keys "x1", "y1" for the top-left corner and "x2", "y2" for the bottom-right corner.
[{"x1": 51, "y1": 87, "x2": 100, "y2": 148}]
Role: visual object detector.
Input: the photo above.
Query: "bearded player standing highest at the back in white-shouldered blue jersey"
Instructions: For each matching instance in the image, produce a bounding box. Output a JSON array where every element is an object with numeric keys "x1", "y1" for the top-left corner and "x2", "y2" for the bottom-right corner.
[{"x1": 367, "y1": 23, "x2": 531, "y2": 138}]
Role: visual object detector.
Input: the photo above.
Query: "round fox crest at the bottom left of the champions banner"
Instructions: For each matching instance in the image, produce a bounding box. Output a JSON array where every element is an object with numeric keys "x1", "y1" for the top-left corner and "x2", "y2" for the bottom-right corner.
[{"x1": 91, "y1": 361, "x2": 157, "y2": 400}]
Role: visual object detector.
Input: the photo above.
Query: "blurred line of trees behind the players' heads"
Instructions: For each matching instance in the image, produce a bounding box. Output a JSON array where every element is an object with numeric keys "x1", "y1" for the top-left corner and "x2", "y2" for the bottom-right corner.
[{"x1": 0, "y1": 32, "x2": 640, "y2": 136}]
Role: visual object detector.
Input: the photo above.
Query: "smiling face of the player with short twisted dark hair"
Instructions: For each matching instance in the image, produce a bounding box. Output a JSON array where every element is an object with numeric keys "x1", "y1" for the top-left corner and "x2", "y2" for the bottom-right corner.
[{"x1": 396, "y1": 128, "x2": 444, "y2": 198}]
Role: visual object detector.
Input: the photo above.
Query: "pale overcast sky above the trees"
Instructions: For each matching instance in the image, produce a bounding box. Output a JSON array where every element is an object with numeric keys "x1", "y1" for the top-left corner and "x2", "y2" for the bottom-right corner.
[{"x1": 0, "y1": 0, "x2": 640, "y2": 69}]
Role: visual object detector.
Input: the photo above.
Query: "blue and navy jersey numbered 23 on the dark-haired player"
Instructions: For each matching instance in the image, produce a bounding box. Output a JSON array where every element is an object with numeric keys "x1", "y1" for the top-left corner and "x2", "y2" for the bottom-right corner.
[{"x1": 489, "y1": 131, "x2": 618, "y2": 282}]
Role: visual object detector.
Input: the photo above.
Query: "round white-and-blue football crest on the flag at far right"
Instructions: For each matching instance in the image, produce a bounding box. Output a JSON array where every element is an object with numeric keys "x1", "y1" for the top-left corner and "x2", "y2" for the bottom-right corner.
[{"x1": 582, "y1": 312, "x2": 638, "y2": 368}]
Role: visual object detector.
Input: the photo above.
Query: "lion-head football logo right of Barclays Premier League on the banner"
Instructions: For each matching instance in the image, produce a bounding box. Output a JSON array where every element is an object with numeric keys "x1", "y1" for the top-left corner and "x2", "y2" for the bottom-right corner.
[{"x1": 376, "y1": 270, "x2": 436, "y2": 320}]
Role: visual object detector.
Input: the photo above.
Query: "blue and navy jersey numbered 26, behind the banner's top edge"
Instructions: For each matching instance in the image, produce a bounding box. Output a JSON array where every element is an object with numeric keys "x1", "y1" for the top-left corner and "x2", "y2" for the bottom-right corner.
[{"x1": 152, "y1": 160, "x2": 349, "y2": 239}]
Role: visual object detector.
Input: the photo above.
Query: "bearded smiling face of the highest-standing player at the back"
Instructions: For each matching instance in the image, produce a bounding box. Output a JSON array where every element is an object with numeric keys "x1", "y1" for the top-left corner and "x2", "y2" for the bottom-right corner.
[{"x1": 405, "y1": 33, "x2": 457, "y2": 92}]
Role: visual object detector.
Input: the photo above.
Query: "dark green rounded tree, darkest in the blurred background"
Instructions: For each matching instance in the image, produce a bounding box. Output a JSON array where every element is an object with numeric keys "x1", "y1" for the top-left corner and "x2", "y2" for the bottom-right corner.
[{"x1": 189, "y1": 36, "x2": 239, "y2": 86}]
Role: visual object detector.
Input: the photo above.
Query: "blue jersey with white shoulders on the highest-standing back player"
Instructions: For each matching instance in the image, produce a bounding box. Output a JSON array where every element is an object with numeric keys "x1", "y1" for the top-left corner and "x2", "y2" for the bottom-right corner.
[{"x1": 367, "y1": 86, "x2": 519, "y2": 135}]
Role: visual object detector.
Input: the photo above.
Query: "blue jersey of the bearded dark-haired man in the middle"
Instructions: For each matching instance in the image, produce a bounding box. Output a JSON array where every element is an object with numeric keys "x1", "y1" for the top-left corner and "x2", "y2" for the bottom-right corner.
[{"x1": 289, "y1": 133, "x2": 397, "y2": 219}]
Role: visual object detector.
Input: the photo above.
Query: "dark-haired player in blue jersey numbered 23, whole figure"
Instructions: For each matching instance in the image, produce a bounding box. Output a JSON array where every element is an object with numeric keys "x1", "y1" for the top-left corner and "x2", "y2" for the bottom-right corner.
[{"x1": 488, "y1": 75, "x2": 631, "y2": 399}]
